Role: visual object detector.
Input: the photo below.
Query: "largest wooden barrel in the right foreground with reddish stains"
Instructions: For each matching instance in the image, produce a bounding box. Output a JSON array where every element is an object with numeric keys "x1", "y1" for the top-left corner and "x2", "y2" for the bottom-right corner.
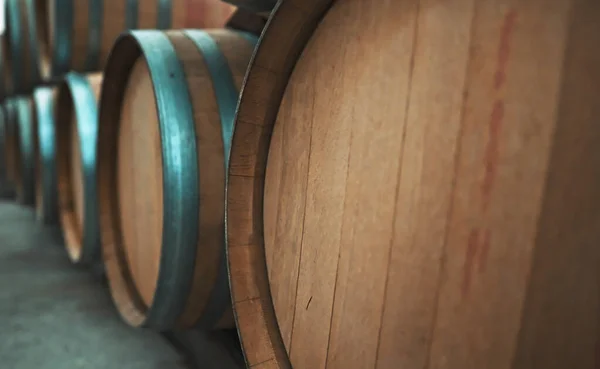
[{"x1": 226, "y1": 0, "x2": 600, "y2": 369}]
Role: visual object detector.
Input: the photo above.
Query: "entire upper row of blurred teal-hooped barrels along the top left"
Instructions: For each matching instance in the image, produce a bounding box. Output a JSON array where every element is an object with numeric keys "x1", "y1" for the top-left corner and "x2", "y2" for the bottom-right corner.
[{"x1": 0, "y1": 0, "x2": 264, "y2": 99}]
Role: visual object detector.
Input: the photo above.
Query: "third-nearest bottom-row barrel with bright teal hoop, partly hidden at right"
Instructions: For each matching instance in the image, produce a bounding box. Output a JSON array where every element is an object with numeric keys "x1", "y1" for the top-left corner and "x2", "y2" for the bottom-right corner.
[{"x1": 55, "y1": 73, "x2": 102, "y2": 268}]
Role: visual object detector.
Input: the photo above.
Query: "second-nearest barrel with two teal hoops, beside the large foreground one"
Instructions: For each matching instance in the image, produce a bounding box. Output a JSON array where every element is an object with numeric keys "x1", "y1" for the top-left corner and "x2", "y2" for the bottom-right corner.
[{"x1": 98, "y1": 30, "x2": 256, "y2": 330}]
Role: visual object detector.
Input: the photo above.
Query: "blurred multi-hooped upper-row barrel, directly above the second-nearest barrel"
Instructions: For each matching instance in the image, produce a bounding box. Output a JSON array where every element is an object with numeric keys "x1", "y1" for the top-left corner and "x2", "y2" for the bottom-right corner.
[{"x1": 36, "y1": 0, "x2": 233, "y2": 76}]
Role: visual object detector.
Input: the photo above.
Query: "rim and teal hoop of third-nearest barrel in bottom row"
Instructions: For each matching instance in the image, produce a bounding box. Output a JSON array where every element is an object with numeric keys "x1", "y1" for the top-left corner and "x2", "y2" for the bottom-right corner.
[{"x1": 55, "y1": 72, "x2": 101, "y2": 266}]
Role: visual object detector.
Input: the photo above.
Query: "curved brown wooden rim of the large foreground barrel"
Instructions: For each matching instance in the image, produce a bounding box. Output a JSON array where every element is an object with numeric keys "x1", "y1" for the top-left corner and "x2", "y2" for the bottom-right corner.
[{"x1": 226, "y1": 0, "x2": 333, "y2": 369}]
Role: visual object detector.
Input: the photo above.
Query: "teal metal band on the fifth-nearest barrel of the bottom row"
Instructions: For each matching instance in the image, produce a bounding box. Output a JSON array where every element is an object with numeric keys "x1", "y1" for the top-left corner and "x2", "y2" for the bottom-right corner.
[{"x1": 16, "y1": 97, "x2": 35, "y2": 205}]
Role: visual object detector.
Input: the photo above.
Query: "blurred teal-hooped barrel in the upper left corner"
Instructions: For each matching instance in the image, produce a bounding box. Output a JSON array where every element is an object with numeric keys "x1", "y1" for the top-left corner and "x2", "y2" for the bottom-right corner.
[{"x1": 5, "y1": 0, "x2": 41, "y2": 94}]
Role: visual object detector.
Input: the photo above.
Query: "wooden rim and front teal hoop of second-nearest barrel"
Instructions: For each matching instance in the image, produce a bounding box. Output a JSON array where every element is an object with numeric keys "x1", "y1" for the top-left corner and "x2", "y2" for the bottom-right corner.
[{"x1": 97, "y1": 30, "x2": 200, "y2": 330}]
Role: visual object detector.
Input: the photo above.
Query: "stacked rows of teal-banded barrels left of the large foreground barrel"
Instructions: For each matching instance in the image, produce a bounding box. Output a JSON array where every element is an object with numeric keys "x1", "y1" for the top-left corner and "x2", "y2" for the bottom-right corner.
[{"x1": 0, "y1": 0, "x2": 274, "y2": 366}]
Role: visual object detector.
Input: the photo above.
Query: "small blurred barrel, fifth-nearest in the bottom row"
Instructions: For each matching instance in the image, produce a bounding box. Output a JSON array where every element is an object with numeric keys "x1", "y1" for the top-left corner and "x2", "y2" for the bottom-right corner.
[{"x1": 13, "y1": 97, "x2": 37, "y2": 206}]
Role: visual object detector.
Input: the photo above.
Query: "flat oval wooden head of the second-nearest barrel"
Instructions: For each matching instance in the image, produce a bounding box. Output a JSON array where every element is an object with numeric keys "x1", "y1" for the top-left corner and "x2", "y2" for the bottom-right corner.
[{"x1": 117, "y1": 58, "x2": 163, "y2": 306}]
